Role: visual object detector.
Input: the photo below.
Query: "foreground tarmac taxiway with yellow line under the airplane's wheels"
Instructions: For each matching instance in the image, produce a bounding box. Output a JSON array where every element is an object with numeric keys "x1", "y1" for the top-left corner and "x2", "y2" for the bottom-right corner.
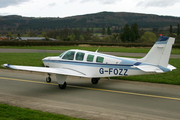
[{"x1": 0, "y1": 69, "x2": 180, "y2": 120}]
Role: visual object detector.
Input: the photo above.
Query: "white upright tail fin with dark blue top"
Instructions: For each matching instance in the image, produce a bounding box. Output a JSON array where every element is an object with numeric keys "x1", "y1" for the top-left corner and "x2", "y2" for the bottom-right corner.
[{"x1": 139, "y1": 36, "x2": 175, "y2": 67}]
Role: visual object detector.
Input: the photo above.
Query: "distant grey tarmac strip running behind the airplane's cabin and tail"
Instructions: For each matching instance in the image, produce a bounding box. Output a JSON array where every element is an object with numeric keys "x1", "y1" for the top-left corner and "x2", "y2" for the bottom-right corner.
[{"x1": 0, "y1": 48, "x2": 180, "y2": 58}]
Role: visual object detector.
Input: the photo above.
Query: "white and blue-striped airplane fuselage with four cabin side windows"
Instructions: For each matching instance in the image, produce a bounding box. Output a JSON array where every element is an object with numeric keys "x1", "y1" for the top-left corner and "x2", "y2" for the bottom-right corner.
[{"x1": 43, "y1": 49, "x2": 154, "y2": 78}]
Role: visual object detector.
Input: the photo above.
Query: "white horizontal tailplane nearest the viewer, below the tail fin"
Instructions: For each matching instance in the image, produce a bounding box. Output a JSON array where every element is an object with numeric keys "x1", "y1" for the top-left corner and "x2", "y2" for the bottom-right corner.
[{"x1": 133, "y1": 65, "x2": 164, "y2": 73}]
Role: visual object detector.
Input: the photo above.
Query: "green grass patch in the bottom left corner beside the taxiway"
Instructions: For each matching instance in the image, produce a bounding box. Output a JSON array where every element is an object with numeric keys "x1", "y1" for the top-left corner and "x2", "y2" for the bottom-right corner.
[{"x1": 0, "y1": 104, "x2": 82, "y2": 120}]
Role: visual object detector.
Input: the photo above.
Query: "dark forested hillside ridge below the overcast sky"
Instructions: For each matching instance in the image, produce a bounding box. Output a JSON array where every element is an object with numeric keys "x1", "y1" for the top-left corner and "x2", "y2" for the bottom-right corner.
[{"x1": 0, "y1": 12, "x2": 180, "y2": 31}]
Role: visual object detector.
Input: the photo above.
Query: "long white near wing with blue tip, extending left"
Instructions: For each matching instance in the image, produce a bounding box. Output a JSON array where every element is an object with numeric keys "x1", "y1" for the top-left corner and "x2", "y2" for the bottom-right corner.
[{"x1": 2, "y1": 64, "x2": 86, "y2": 77}]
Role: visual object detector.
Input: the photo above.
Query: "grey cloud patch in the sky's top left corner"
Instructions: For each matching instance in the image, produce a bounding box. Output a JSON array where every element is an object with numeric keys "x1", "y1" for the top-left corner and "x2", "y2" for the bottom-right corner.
[{"x1": 0, "y1": 0, "x2": 30, "y2": 8}]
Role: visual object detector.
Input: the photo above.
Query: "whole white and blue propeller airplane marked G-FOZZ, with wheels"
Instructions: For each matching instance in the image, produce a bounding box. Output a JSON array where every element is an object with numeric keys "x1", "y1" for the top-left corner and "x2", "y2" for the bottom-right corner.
[{"x1": 2, "y1": 36, "x2": 176, "y2": 89}]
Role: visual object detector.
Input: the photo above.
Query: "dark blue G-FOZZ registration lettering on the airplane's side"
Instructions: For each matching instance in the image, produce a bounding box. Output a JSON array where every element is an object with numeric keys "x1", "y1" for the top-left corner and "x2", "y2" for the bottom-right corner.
[{"x1": 99, "y1": 68, "x2": 128, "y2": 76}]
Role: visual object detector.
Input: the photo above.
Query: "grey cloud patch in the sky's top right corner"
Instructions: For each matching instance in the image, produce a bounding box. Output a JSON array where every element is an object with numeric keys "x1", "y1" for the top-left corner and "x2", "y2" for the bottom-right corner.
[{"x1": 137, "y1": 0, "x2": 180, "y2": 8}]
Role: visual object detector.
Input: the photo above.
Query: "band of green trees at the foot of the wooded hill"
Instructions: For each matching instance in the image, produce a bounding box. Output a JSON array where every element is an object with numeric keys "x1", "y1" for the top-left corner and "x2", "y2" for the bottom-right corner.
[{"x1": 2, "y1": 23, "x2": 180, "y2": 43}]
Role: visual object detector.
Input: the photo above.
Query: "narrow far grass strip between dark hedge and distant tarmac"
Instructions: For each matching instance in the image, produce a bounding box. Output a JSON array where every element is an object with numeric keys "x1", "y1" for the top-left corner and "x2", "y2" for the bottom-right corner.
[{"x1": 1, "y1": 46, "x2": 180, "y2": 54}]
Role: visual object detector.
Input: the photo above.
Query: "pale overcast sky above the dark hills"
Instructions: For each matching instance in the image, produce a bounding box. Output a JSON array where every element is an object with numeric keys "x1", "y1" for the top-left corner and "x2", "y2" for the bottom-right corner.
[{"x1": 0, "y1": 0, "x2": 180, "y2": 18}]
